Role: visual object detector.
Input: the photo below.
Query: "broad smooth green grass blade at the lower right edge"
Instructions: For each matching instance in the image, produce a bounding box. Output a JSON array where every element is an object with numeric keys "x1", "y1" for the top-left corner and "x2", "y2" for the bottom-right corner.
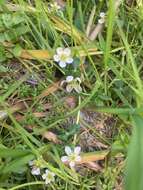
[{"x1": 125, "y1": 115, "x2": 143, "y2": 190}]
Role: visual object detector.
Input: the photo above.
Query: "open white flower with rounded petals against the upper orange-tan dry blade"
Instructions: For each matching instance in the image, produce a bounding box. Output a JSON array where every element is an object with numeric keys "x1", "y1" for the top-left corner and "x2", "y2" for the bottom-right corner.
[{"x1": 54, "y1": 47, "x2": 73, "y2": 68}]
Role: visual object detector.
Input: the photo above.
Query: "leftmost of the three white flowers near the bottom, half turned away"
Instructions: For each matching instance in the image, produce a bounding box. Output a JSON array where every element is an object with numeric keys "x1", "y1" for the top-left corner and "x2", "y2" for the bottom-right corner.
[{"x1": 29, "y1": 159, "x2": 43, "y2": 175}]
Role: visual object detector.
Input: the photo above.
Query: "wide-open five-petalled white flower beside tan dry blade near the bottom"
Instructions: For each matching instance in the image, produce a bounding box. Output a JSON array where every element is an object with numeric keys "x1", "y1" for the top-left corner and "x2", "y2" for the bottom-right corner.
[{"x1": 61, "y1": 146, "x2": 81, "y2": 168}]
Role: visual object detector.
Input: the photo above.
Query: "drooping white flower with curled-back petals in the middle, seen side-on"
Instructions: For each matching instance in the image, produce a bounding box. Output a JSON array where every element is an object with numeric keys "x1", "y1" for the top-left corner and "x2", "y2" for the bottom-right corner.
[{"x1": 61, "y1": 76, "x2": 82, "y2": 93}]
